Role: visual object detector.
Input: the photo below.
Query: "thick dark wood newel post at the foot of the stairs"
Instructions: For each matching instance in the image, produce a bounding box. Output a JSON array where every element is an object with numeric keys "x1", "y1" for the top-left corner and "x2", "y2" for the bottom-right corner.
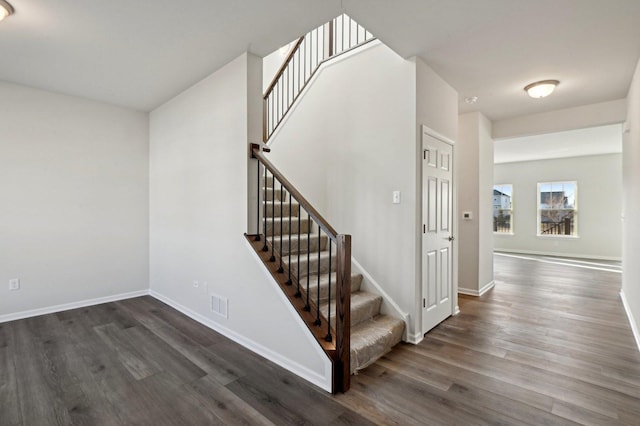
[{"x1": 333, "y1": 234, "x2": 351, "y2": 393}]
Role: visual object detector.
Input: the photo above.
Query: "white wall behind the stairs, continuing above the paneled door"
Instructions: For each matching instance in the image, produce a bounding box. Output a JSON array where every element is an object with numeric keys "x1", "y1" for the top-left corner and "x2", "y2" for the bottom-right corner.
[{"x1": 269, "y1": 42, "x2": 457, "y2": 340}]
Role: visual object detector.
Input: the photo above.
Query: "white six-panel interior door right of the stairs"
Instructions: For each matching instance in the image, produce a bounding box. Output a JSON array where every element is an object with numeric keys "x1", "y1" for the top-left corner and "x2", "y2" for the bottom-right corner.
[{"x1": 422, "y1": 133, "x2": 453, "y2": 333}]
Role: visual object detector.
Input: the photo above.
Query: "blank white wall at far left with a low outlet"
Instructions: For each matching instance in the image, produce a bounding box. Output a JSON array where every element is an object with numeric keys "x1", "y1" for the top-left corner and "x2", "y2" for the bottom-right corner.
[{"x1": 0, "y1": 82, "x2": 149, "y2": 321}]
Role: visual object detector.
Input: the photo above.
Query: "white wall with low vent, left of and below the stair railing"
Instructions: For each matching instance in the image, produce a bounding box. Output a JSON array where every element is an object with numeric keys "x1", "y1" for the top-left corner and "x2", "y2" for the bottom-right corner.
[{"x1": 150, "y1": 54, "x2": 330, "y2": 389}]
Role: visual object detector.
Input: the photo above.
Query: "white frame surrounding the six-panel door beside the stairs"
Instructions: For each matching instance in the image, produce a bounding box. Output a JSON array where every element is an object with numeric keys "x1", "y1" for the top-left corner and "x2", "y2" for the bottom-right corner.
[{"x1": 415, "y1": 124, "x2": 460, "y2": 340}]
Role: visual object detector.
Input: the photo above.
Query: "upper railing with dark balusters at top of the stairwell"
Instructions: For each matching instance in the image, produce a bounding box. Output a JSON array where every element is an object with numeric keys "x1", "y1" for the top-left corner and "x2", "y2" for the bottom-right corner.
[{"x1": 262, "y1": 15, "x2": 375, "y2": 142}]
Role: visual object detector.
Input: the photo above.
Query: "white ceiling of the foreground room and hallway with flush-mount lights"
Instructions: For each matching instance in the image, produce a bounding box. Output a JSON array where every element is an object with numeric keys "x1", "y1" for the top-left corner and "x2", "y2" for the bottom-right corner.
[{"x1": 0, "y1": 0, "x2": 640, "y2": 120}]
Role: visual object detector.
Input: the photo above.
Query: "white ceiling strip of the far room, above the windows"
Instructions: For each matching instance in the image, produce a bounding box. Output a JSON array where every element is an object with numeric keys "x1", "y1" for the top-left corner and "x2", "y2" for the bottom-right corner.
[{"x1": 493, "y1": 124, "x2": 622, "y2": 165}]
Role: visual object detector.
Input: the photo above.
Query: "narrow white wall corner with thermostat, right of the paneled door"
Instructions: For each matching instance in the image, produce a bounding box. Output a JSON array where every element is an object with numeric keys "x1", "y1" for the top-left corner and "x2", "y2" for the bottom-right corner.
[{"x1": 456, "y1": 112, "x2": 493, "y2": 296}]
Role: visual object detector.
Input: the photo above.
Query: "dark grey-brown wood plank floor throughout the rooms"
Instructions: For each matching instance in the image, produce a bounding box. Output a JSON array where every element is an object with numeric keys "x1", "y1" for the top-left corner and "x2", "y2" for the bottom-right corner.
[{"x1": 0, "y1": 255, "x2": 640, "y2": 426}]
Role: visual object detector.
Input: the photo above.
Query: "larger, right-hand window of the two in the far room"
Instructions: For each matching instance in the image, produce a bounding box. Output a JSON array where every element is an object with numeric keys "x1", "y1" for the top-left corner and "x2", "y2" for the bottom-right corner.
[{"x1": 538, "y1": 182, "x2": 578, "y2": 237}]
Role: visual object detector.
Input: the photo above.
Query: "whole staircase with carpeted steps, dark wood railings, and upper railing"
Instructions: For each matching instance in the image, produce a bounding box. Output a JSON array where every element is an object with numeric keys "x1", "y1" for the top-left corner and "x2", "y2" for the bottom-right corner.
[{"x1": 246, "y1": 15, "x2": 405, "y2": 393}]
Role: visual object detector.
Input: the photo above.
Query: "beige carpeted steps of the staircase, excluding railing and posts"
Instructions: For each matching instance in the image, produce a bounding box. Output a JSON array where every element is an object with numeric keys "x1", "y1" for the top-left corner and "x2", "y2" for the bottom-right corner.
[{"x1": 262, "y1": 175, "x2": 405, "y2": 374}]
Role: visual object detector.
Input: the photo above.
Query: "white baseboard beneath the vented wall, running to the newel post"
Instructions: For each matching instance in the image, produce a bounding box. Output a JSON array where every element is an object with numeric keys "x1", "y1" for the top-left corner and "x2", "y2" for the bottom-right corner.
[{"x1": 149, "y1": 290, "x2": 331, "y2": 392}]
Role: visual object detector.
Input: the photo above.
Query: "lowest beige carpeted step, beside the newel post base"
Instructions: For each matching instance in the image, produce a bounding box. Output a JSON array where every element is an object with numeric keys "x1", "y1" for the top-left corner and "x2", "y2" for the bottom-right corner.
[{"x1": 351, "y1": 315, "x2": 404, "y2": 374}]
